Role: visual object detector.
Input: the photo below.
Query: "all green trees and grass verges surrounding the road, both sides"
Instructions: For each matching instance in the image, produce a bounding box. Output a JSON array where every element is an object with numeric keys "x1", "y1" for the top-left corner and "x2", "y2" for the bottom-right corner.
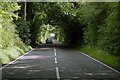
[{"x1": 0, "y1": 2, "x2": 120, "y2": 70}]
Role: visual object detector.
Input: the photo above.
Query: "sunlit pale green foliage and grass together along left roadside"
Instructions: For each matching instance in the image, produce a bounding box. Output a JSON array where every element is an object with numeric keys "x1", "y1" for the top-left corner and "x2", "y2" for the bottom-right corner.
[{"x1": 0, "y1": 2, "x2": 31, "y2": 64}]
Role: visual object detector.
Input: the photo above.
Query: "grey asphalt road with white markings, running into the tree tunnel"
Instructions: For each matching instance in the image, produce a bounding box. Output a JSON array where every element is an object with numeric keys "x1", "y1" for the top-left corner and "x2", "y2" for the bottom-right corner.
[{"x1": 2, "y1": 41, "x2": 120, "y2": 80}]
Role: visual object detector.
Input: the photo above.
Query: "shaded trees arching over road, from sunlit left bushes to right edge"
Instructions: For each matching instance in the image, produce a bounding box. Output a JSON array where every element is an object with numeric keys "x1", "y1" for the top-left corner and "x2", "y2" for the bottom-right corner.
[{"x1": 13, "y1": 2, "x2": 120, "y2": 54}]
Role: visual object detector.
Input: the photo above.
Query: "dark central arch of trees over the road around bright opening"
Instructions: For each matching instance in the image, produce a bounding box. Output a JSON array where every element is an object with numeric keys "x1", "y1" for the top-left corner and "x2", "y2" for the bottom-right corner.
[{"x1": 16, "y1": 2, "x2": 83, "y2": 45}]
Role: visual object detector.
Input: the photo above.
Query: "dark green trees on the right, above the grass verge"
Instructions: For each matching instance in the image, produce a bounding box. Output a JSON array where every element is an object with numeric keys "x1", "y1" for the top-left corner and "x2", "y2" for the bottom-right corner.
[{"x1": 82, "y1": 3, "x2": 120, "y2": 54}]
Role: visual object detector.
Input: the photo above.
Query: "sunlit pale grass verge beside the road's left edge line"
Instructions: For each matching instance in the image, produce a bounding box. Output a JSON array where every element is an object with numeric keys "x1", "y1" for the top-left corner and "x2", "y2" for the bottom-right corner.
[{"x1": 0, "y1": 45, "x2": 32, "y2": 64}]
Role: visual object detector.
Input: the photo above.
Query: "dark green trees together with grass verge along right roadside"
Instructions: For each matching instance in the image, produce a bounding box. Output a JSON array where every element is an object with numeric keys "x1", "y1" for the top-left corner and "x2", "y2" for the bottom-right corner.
[{"x1": 77, "y1": 3, "x2": 120, "y2": 71}]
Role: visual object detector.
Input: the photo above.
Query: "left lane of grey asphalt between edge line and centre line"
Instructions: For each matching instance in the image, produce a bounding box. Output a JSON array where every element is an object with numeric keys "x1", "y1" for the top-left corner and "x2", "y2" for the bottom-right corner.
[{"x1": 3, "y1": 48, "x2": 55, "y2": 78}]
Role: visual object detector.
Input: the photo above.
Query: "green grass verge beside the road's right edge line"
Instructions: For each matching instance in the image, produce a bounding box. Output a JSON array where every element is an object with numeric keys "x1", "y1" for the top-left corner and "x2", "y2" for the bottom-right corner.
[{"x1": 76, "y1": 46, "x2": 120, "y2": 71}]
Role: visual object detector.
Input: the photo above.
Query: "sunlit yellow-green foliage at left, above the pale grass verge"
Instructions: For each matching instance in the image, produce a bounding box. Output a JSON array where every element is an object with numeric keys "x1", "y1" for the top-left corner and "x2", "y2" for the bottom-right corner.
[{"x1": 0, "y1": 2, "x2": 19, "y2": 49}]
